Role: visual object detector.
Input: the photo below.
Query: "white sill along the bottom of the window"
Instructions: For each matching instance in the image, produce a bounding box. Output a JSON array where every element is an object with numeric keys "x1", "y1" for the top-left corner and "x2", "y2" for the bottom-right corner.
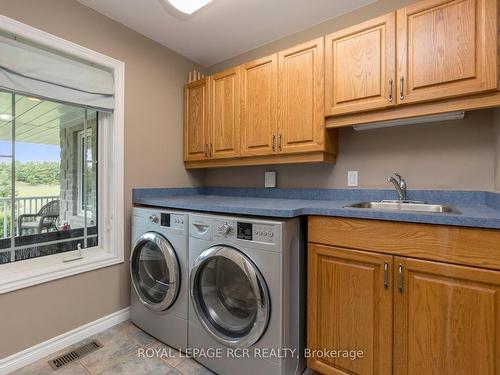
[{"x1": 0, "y1": 247, "x2": 123, "y2": 294}]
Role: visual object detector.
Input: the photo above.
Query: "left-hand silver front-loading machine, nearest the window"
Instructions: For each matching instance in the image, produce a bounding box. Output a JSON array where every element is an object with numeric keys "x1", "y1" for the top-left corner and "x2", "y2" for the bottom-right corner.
[{"x1": 130, "y1": 207, "x2": 189, "y2": 350}]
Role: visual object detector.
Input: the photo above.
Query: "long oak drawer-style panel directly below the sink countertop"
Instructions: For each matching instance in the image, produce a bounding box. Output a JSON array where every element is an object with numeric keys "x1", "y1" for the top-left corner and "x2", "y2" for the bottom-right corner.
[{"x1": 308, "y1": 216, "x2": 500, "y2": 270}]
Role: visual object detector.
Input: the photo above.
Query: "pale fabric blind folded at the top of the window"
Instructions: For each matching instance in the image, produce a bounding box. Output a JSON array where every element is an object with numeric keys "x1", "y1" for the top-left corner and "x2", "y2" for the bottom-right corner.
[{"x1": 0, "y1": 35, "x2": 115, "y2": 111}]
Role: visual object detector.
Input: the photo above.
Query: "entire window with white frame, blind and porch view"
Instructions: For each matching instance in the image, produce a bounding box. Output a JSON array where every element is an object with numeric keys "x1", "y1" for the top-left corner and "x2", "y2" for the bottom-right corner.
[{"x1": 0, "y1": 15, "x2": 124, "y2": 294}]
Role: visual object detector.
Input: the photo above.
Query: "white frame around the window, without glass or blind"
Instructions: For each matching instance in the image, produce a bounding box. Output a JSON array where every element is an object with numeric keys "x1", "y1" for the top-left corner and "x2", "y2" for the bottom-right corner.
[{"x1": 0, "y1": 15, "x2": 125, "y2": 294}]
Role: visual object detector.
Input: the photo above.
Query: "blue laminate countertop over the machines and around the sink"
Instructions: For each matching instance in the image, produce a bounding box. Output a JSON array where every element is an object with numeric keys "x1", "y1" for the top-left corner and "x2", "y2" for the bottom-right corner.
[{"x1": 133, "y1": 188, "x2": 500, "y2": 229}]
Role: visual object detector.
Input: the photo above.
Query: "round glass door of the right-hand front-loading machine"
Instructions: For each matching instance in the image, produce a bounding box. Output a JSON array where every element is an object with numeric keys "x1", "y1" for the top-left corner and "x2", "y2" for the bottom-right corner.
[{"x1": 190, "y1": 245, "x2": 271, "y2": 348}]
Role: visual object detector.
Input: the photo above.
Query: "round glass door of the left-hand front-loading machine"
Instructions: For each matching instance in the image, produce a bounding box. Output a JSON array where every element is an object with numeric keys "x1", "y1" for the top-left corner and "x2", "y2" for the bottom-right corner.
[{"x1": 130, "y1": 232, "x2": 181, "y2": 312}]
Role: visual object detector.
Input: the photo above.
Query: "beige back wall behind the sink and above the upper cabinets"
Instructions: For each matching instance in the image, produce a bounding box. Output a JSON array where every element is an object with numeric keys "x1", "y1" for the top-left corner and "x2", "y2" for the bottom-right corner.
[{"x1": 205, "y1": 0, "x2": 500, "y2": 190}]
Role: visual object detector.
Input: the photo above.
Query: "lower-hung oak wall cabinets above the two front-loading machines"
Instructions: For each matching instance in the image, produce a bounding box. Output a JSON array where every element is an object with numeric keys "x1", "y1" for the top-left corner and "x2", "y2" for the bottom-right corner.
[{"x1": 185, "y1": 38, "x2": 337, "y2": 168}]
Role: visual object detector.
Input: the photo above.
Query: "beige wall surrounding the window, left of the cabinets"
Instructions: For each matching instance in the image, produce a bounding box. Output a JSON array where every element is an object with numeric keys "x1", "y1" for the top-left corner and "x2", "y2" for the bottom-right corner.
[{"x1": 0, "y1": 0, "x2": 202, "y2": 358}]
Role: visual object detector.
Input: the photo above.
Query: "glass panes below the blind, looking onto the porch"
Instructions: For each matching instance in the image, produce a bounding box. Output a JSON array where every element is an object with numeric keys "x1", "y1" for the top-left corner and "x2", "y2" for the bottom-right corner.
[{"x1": 0, "y1": 92, "x2": 99, "y2": 263}]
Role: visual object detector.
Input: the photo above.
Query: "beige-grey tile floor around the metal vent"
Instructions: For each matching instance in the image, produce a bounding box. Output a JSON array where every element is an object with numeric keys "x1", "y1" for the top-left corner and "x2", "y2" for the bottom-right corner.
[{"x1": 11, "y1": 321, "x2": 315, "y2": 375}]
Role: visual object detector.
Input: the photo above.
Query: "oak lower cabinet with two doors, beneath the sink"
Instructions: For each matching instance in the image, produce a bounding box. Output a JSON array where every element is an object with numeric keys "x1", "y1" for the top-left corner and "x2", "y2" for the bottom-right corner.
[{"x1": 307, "y1": 218, "x2": 500, "y2": 375}]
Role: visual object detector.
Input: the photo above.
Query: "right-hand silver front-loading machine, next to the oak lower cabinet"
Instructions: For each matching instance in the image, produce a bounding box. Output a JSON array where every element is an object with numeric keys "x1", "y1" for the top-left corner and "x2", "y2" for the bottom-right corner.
[{"x1": 188, "y1": 214, "x2": 306, "y2": 375}]
